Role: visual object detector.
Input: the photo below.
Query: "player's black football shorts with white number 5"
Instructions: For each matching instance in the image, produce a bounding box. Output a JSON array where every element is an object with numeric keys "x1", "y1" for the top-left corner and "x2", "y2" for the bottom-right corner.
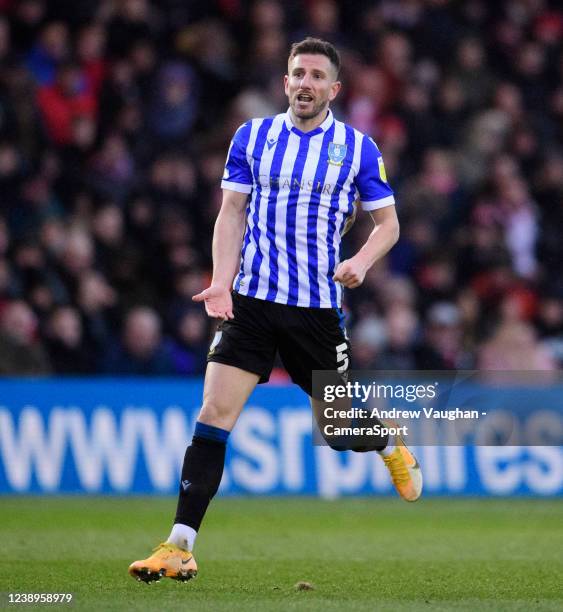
[{"x1": 207, "y1": 292, "x2": 350, "y2": 395}]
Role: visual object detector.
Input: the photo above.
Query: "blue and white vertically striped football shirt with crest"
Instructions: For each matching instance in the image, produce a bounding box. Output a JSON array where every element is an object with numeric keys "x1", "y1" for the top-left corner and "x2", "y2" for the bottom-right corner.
[{"x1": 221, "y1": 110, "x2": 395, "y2": 308}]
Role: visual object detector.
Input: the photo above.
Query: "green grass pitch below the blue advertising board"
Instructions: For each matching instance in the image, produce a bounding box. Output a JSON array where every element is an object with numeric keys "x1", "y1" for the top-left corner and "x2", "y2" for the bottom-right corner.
[{"x1": 0, "y1": 497, "x2": 563, "y2": 612}]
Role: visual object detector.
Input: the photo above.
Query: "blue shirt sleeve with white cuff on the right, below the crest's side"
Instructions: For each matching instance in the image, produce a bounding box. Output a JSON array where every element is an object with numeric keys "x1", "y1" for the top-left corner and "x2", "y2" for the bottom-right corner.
[{"x1": 355, "y1": 136, "x2": 395, "y2": 210}]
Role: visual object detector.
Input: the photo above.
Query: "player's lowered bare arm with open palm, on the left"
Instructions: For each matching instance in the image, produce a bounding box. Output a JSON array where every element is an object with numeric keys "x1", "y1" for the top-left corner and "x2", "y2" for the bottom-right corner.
[{"x1": 192, "y1": 189, "x2": 248, "y2": 319}]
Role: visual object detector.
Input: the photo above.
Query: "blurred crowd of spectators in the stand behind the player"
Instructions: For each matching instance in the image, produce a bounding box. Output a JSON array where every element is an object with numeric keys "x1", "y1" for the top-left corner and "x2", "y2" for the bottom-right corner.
[{"x1": 0, "y1": 0, "x2": 563, "y2": 379}]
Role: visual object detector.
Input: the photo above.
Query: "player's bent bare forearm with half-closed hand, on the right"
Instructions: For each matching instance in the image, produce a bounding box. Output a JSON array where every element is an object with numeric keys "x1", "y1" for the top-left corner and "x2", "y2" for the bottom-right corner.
[{"x1": 333, "y1": 206, "x2": 399, "y2": 289}]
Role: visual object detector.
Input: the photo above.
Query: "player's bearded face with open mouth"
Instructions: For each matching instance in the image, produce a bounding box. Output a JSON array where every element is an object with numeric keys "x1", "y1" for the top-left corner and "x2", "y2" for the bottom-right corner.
[{"x1": 284, "y1": 54, "x2": 340, "y2": 120}]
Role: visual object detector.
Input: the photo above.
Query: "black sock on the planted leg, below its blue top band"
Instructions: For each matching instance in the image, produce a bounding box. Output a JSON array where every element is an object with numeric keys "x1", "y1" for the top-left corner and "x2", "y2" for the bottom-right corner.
[{"x1": 174, "y1": 435, "x2": 227, "y2": 531}]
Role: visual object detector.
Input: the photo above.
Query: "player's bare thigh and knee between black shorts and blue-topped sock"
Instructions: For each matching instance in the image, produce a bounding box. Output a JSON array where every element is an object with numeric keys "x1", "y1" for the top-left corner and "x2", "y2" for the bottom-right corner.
[{"x1": 198, "y1": 362, "x2": 260, "y2": 431}]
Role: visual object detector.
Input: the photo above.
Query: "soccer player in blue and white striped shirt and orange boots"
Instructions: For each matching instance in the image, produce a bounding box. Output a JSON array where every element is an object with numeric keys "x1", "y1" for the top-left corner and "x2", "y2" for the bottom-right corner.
[{"x1": 129, "y1": 38, "x2": 422, "y2": 582}]
